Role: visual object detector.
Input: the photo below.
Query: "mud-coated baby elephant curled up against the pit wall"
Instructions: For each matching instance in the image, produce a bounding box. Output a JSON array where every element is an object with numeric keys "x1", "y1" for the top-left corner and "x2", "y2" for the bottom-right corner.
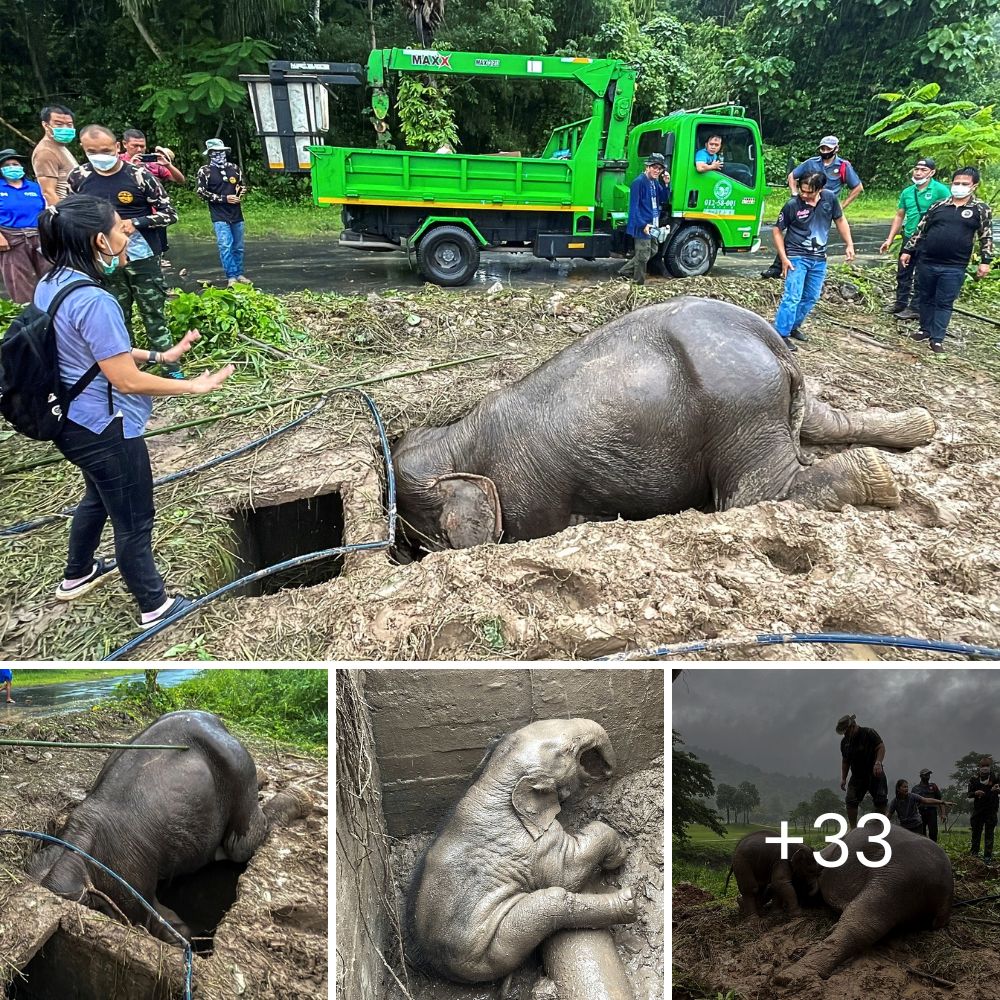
[{"x1": 406, "y1": 719, "x2": 637, "y2": 983}]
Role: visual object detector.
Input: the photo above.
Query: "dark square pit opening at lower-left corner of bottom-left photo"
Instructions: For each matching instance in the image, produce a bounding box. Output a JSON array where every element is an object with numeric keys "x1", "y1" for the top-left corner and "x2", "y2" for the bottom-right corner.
[{"x1": 5, "y1": 930, "x2": 181, "y2": 1000}]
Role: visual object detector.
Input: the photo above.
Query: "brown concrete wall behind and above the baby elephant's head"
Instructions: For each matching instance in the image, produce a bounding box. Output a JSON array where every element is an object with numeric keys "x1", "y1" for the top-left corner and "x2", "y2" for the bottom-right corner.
[{"x1": 365, "y1": 667, "x2": 665, "y2": 837}]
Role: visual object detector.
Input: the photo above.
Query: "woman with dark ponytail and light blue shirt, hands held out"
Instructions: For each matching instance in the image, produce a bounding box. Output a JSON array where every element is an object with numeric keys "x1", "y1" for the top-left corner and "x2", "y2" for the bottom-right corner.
[{"x1": 34, "y1": 195, "x2": 234, "y2": 626}]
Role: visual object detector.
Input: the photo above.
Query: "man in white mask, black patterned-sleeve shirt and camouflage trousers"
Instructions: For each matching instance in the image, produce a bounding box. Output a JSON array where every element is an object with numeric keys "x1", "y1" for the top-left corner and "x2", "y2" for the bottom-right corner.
[{"x1": 66, "y1": 125, "x2": 184, "y2": 378}]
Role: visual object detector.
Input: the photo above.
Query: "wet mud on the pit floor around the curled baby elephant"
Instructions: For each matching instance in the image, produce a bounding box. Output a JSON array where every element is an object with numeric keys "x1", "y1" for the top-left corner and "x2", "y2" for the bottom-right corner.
[{"x1": 382, "y1": 766, "x2": 664, "y2": 1000}]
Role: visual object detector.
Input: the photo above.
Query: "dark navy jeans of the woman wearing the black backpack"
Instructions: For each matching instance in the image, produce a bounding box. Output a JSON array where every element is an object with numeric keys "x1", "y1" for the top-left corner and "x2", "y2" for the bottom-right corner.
[{"x1": 55, "y1": 418, "x2": 167, "y2": 611}]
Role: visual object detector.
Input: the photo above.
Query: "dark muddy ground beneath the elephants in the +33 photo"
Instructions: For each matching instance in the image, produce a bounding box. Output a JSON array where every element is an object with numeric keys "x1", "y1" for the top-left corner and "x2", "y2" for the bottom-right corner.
[{"x1": 672, "y1": 858, "x2": 1000, "y2": 1000}]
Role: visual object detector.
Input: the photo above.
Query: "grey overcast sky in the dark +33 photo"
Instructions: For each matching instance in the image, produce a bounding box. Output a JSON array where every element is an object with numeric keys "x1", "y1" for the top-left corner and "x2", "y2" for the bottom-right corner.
[{"x1": 673, "y1": 667, "x2": 1000, "y2": 788}]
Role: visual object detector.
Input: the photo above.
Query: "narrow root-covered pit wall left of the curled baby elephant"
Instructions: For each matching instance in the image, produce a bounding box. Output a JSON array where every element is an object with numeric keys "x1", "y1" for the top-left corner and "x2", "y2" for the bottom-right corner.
[{"x1": 335, "y1": 670, "x2": 393, "y2": 1000}]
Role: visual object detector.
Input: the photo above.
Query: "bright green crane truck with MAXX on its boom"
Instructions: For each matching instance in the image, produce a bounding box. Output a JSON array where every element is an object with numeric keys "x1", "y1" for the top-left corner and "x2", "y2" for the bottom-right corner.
[{"x1": 245, "y1": 49, "x2": 766, "y2": 285}]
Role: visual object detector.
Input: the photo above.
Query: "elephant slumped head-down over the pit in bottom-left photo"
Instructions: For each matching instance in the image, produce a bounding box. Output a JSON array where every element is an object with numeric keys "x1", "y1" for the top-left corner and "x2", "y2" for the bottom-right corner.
[{"x1": 28, "y1": 711, "x2": 310, "y2": 943}]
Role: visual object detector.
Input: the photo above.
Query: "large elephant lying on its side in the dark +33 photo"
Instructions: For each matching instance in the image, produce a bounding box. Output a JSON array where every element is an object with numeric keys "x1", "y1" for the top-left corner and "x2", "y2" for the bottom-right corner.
[{"x1": 775, "y1": 825, "x2": 955, "y2": 985}]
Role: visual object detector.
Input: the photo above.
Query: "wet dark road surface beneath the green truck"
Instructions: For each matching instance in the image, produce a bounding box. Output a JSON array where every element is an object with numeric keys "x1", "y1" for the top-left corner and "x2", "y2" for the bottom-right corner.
[{"x1": 165, "y1": 222, "x2": 888, "y2": 294}]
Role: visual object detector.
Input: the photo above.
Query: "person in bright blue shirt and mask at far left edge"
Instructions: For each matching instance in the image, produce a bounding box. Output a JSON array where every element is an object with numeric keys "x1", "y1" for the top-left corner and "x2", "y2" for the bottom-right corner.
[{"x1": 0, "y1": 149, "x2": 49, "y2": 303}]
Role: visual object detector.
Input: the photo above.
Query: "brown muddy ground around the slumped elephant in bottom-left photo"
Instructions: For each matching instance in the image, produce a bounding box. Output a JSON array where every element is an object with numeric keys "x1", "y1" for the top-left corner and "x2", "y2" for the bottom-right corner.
[{"x1": 0, "y1": 710, "x2": 328, "y2": 1000}]
